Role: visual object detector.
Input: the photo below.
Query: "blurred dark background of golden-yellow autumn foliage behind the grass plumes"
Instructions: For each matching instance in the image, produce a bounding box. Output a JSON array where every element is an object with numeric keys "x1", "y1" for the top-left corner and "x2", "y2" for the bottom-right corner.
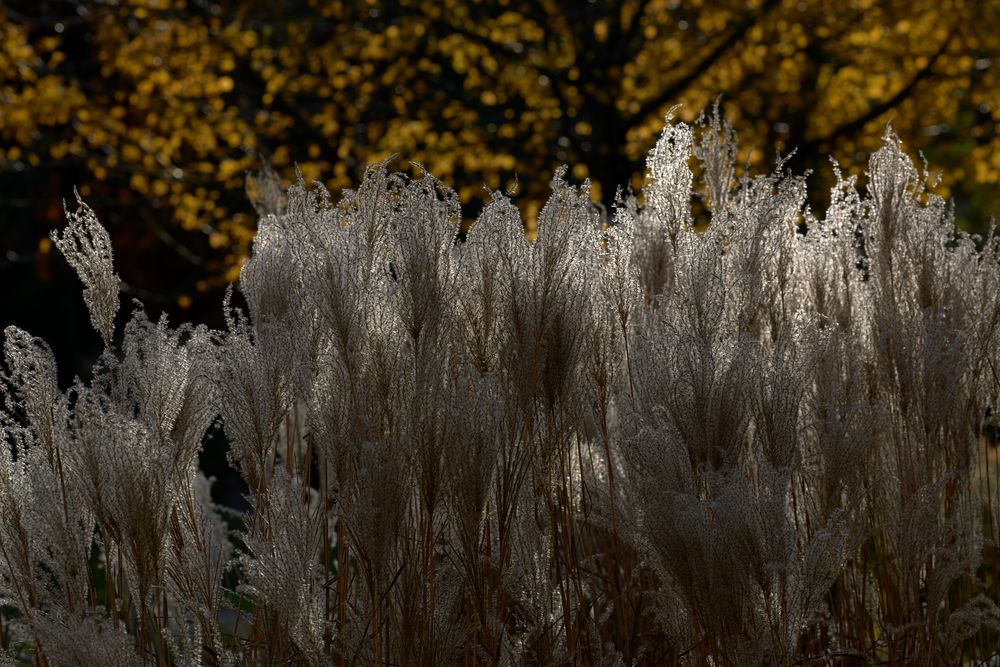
[{"x1": 0, "y1": 0, "x2": 1000, "y2": 370}]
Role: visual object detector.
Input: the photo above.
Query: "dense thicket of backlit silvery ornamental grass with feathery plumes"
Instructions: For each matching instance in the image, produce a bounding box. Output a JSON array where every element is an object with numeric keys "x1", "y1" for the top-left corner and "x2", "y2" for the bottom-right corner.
[{"x1": 0, "y1": 112, "x2": 1000, "y2": 665}]
